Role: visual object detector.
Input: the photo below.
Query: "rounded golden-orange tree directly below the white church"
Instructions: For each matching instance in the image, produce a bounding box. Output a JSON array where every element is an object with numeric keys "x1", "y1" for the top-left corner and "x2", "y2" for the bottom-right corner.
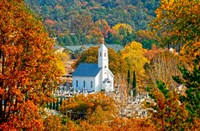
[{"x1": 60, "y1": 93, "x2": 117, "y2": 121}]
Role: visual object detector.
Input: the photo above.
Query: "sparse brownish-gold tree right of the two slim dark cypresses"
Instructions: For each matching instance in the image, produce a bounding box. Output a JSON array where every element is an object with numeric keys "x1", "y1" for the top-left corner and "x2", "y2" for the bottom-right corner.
[{"x1": 146, "y1": 51, "x2": 181, "y2": 90}]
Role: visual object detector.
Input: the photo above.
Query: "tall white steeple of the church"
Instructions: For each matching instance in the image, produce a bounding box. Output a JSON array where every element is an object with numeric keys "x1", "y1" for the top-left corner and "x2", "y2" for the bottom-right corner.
[{"x1": 98, "y1": 44, "x2": 108, "y2": 70}]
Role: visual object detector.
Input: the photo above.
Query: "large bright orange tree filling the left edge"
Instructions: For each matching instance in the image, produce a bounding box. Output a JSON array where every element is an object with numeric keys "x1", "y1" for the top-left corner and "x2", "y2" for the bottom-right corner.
[{"x1": 0, "y1": 0, "x2": 61, "y2": 130}]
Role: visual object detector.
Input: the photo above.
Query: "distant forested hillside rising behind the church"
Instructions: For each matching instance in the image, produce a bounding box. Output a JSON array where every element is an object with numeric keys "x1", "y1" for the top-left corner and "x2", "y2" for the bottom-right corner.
[{"x1": 25, "y1": 0, "x2": 160, "y2": 48}]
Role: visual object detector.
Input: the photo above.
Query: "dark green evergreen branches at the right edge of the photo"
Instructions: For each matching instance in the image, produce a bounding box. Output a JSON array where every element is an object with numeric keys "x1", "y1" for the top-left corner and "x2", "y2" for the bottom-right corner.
[{"x1": 173, "y1": 55, "x2": 200, "y2": 118}]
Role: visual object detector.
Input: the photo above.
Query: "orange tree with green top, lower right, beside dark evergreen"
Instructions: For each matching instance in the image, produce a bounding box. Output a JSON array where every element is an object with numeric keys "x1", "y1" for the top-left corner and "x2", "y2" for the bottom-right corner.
[{"x1": 146, "y1": 81, "x2": 189, "y2": 131}]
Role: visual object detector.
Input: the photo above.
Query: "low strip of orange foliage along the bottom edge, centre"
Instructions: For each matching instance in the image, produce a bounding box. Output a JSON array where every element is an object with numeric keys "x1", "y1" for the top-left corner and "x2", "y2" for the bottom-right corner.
[{"x1": 66, "y1": 117, "x2": 156, "y2": 131}]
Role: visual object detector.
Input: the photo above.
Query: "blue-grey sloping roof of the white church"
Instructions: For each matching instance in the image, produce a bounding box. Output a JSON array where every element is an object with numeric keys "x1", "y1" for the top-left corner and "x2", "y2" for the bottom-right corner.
[{"x1": 73, "y1": 63, "x2": 101, "y2": 77}]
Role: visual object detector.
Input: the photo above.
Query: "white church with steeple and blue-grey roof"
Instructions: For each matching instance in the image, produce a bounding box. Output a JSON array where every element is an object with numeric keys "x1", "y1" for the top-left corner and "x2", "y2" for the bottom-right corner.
[{"x1": 72, "y1": 44, "x2": 114, "y2": 93}]
